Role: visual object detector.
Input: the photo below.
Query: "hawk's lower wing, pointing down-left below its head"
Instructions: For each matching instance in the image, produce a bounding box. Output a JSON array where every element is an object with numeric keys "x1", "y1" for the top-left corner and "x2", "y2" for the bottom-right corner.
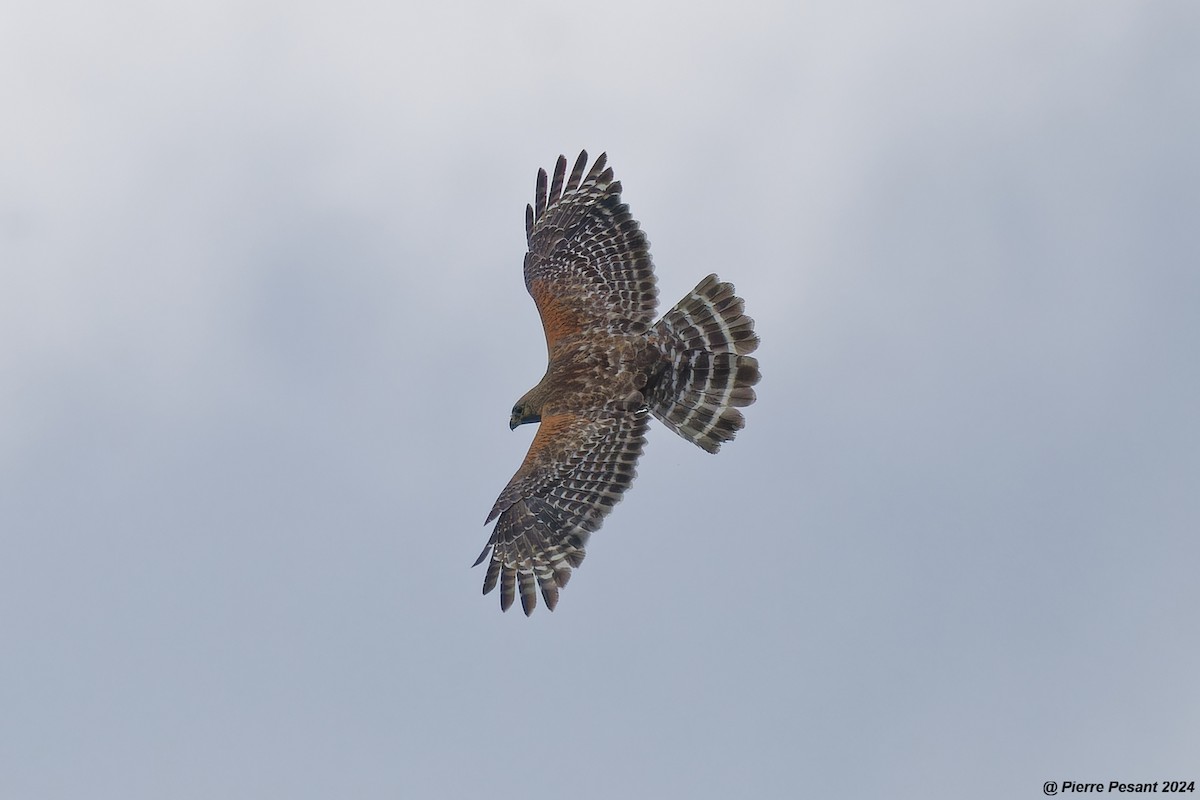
[{"x1": 475, "y1": 409, "x2": 649, "y2": 614}]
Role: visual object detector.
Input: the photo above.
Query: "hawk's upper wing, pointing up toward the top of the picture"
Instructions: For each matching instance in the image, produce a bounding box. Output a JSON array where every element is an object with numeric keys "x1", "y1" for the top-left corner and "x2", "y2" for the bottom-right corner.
[{"x1": 524, "y1": 151, "x2": 659, "y2": 354}]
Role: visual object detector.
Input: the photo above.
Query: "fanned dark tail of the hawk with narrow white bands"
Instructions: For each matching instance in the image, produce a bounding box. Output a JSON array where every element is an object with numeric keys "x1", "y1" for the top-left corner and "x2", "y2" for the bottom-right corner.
[{"x1": 648, "y1": 275, "x2": 761, "y2": 452}]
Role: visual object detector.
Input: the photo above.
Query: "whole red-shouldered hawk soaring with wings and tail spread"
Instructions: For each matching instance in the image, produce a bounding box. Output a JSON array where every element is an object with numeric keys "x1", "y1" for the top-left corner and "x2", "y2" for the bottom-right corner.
[{"x1": 475, "y1": 152, "x2": 760, "y2": 614}]
